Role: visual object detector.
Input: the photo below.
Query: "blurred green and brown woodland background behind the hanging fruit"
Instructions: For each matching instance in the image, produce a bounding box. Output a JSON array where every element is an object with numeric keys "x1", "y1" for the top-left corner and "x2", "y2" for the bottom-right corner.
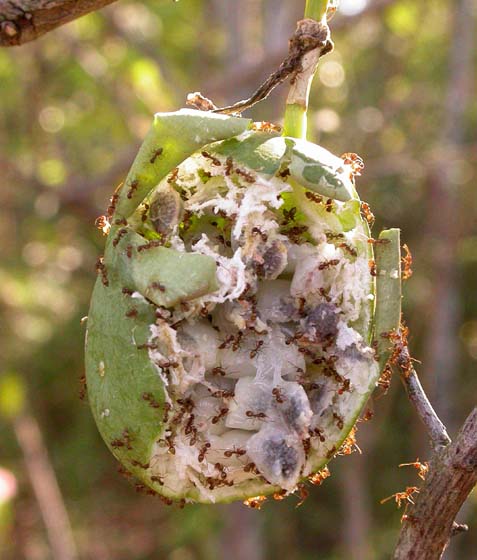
[{"x1": 0, "y1": 0, "x2": 477, "y2": 560}]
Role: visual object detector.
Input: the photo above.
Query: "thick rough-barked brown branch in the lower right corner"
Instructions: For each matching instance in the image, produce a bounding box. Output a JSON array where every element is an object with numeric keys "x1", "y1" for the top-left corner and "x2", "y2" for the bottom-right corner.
[{"x1": 393, "y1": 408, "x2": 477, "y2": 560}]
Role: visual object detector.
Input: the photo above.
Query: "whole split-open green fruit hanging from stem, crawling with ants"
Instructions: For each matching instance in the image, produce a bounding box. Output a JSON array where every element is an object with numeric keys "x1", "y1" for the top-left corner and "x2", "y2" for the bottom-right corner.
[{"x1": 86, "y1": 110, "x2": 401, "y2": 504}]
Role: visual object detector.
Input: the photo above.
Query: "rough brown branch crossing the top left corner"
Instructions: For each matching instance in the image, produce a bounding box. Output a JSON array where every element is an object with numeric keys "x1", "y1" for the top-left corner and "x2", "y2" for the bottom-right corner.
[{"x1": 0, "y1": 0, "x2": 115, "y2": 47}]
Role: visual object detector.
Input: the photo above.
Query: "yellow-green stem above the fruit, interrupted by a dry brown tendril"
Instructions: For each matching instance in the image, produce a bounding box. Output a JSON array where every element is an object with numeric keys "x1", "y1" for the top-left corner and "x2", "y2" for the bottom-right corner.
[{"x1": 283, "y1": 0, "x2": 330, "y2": 139}]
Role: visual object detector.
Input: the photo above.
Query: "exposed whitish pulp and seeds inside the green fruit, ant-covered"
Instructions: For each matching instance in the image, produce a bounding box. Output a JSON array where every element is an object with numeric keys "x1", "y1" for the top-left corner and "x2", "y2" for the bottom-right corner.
[{"x1": 120, "y1": 147, "x2": 378, "y2": 502}]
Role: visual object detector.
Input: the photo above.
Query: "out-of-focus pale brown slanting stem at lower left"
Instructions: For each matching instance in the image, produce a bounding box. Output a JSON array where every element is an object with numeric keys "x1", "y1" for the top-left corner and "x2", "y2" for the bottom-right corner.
[{"x1": 13, "y1": 413, "x2": 77, "y2": 560}]
